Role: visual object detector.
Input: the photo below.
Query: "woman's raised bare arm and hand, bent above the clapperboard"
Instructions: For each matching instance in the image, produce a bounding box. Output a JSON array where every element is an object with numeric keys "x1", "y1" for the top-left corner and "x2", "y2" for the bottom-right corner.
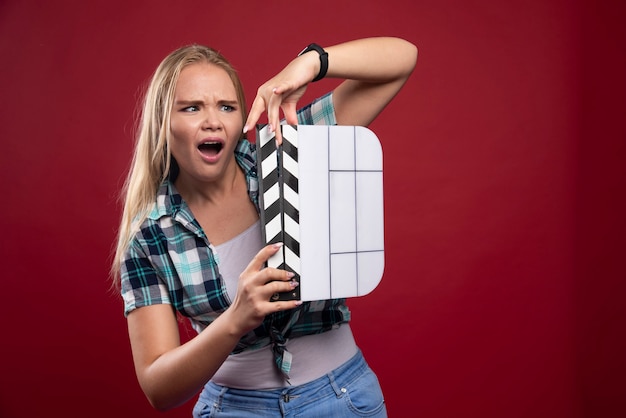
[{"x1": 244, "y1": 37, "x2": 417, "y2": 136}]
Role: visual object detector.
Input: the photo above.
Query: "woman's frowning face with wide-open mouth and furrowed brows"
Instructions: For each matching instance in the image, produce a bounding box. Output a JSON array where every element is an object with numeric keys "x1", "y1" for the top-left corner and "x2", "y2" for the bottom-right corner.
[{"x1": 170, "y1": 63, "x2": 243, "y2": 187}]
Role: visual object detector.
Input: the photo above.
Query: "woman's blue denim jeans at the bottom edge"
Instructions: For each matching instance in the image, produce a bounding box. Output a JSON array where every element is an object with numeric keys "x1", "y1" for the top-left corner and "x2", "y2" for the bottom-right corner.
[{"x1": 193, "y1": 351, "x2": 387, "y2": 418}]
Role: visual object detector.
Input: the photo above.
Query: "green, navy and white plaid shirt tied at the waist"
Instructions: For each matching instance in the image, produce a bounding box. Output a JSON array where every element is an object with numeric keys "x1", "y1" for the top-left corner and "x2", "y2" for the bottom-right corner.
[{"x1": 121, "y1": 93, "x2": 350, "y2": 362}]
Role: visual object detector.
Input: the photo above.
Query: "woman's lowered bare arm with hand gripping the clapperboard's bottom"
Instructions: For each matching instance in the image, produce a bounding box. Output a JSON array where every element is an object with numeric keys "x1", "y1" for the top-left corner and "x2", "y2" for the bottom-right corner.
[{"x1": 128, "y1": 244, "x2": 301, "y2": 410}]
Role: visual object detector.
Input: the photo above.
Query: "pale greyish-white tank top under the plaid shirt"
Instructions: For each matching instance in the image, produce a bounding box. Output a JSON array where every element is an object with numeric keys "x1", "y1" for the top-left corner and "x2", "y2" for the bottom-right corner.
[{"x1": 211, "y1": 221, "x2": 358, "y2": 390}]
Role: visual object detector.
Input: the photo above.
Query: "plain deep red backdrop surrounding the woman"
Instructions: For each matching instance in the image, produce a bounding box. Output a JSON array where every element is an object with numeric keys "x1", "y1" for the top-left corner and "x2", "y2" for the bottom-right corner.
[{"x1": 0, "y1": 0, "x2": 626, "y2": 418}]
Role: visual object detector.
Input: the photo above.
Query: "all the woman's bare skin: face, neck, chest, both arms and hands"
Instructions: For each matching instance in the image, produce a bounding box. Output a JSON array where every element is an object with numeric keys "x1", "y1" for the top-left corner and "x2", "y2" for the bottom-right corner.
[{"x1": 128, "y1": 38, "x2": 417, "y2": 410}]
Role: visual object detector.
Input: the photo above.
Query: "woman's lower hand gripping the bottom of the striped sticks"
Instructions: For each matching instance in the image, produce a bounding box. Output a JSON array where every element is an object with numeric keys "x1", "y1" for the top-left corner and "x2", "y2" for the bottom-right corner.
[{"x1": 228, "y1": 243, "x2": 302, "y2": 335}]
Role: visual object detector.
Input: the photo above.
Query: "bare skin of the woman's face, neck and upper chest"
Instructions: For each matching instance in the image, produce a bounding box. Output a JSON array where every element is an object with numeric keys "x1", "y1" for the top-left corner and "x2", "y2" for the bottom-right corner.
[{"x1": 170, "y1": 63, "x2": 258, "y2": 245}]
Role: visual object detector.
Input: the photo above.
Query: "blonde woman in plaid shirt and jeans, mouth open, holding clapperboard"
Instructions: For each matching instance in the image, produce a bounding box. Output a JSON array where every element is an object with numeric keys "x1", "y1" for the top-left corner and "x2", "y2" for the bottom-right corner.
[{"x1": 113, "y1": 38, "x2": 417, "y2": 417}]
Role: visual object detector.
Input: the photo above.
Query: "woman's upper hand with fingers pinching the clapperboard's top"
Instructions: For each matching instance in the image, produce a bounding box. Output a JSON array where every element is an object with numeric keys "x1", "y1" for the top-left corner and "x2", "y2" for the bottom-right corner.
[{"x1": 244, "y1": 53, "x2": 319, "y2": 144}]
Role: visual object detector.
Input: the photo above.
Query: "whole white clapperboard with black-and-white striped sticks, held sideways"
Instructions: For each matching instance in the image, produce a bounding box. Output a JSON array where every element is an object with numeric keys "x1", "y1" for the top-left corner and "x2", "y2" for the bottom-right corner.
[{"x1": 256, "y1": 125, "x2": 385, "y2": 301}]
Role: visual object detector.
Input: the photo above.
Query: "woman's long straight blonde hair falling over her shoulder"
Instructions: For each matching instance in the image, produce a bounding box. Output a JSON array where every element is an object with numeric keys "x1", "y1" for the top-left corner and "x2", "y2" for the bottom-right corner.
[{"x1": 111, "y1": 45, "x2": 247, "y2": 285}]
